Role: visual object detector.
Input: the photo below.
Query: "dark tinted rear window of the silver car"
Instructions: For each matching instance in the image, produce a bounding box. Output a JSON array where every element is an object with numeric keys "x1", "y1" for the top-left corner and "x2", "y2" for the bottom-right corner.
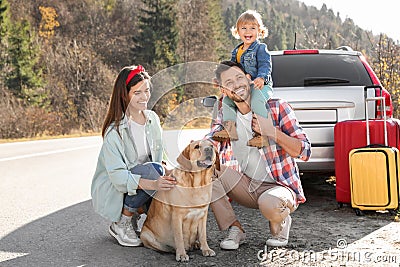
[{"x1": 272, "y1": 54, "x2": 372, "y2": 87}]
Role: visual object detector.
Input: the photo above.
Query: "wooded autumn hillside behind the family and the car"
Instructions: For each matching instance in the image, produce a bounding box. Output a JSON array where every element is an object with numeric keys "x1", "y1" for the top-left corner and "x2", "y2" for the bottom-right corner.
[{"x1": 0, "y1": 0, "x2": 400, "y2": 139}]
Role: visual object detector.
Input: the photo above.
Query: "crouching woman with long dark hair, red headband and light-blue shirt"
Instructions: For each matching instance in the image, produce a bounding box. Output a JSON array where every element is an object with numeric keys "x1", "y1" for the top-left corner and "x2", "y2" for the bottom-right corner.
[{"x1": 91, "y1": 65, "x2": 175, "y2": 246}]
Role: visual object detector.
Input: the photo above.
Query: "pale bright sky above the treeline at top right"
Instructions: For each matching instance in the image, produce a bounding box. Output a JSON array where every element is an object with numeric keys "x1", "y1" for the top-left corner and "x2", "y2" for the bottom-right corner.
[{"x1": 299, "y1": 0, "x2": 400, "y2": 42}]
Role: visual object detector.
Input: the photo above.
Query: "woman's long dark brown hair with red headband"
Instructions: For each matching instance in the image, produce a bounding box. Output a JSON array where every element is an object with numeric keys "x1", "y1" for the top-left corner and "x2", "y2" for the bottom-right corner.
[{"x1": 101, "y1": 65, "x2": 150, "y2": 138}]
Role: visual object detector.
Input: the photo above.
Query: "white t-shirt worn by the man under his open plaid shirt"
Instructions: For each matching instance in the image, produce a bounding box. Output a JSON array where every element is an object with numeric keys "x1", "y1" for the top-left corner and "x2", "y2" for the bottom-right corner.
[{"x1": 231, "y1": 111, "x2": 275, "y2": 183}]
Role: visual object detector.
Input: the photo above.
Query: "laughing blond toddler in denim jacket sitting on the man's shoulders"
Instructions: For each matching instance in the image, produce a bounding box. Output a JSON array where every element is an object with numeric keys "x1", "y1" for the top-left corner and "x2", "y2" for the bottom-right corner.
[{"x1": 213, "y1": 10, "x2": 273, "y2": 148}]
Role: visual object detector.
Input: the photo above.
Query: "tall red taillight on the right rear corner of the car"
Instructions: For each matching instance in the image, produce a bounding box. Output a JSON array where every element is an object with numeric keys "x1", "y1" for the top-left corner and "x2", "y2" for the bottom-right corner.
[{"x1": 360, "y1": 56, "x2": 393, "y2": 119}]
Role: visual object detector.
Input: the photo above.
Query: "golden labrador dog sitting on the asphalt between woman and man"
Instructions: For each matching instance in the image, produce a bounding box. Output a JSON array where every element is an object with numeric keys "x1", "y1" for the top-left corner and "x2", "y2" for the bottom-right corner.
[{"x1": 140, "y1": 140, "x2": 219, "y2": 261}]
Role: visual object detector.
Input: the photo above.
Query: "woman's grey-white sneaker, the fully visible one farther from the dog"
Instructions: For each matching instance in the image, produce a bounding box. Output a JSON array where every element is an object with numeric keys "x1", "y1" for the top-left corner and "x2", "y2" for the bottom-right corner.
[{"x1": 108, "y1": 218, "x2": 142, "y2": 247}]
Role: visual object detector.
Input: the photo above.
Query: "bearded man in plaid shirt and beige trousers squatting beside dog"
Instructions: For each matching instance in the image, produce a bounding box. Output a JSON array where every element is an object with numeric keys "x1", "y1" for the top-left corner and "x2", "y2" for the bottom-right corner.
[{"x1": 211, "y1": 61, "x2": 311, "y2": 249}]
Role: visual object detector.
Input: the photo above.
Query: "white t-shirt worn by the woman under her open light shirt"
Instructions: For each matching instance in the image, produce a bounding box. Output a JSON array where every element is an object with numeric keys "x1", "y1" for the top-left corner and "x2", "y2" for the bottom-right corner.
[{"x1": 129, "y1": 120, "x2": 151, "y2": 164}]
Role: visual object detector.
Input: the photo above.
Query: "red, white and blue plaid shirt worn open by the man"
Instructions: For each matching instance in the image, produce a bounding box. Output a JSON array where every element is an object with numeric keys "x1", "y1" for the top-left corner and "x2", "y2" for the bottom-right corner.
[{"x1": 208, "y1": 99, "x2": 311, "y2": 203}]
